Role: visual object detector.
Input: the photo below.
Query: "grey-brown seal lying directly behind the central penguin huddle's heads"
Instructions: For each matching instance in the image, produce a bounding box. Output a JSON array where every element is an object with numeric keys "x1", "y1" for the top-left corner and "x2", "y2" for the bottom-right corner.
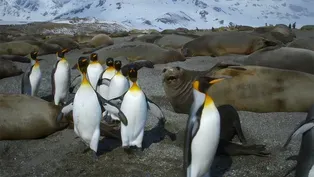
[{"x1": 86, "y1": 42, "x2": 185, "y2": 64}]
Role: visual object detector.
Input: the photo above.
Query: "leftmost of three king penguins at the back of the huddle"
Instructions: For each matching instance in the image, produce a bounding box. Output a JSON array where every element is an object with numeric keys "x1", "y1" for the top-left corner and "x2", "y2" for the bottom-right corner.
[{"x1": 87, "y1": 53, "x2": 104, "y2": 90}]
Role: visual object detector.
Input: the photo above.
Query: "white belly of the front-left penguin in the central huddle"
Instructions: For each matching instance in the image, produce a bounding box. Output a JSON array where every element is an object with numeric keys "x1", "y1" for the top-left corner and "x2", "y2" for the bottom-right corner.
[{"x1": 73, "y1": 86, "x2": 102, "y2": 147}]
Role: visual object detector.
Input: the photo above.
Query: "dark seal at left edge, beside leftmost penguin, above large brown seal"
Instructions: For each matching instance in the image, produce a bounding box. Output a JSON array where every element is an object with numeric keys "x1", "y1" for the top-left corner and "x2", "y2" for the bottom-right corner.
[{"x1": 0, "y1": 59, "x2": 24, "y2": 79}]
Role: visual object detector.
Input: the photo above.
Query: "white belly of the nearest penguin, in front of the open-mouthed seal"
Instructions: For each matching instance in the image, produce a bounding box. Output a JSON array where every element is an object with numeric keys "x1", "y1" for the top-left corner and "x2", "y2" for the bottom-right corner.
[{"x1": 190, "y1": 107, "x2": 220, "y2": 177}]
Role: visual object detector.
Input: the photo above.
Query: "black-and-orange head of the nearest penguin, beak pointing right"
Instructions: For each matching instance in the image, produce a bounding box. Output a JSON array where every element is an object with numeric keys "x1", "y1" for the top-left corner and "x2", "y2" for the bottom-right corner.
[{"x1": 193, "y1": 77, "x2": 225, "y2": 93}]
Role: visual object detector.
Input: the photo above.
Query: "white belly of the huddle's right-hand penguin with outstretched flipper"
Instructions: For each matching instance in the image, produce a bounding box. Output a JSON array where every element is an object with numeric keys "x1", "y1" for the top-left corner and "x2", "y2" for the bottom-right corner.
[{"x1": 120, "y1": 90, "x2": 147, "y2": 148}]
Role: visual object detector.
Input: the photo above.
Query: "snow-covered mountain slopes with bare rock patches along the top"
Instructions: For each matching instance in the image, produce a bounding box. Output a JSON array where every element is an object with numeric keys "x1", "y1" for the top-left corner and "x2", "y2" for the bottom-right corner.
[{"x1": 0, "y1": 0, "x2": 314, "y2": 29}]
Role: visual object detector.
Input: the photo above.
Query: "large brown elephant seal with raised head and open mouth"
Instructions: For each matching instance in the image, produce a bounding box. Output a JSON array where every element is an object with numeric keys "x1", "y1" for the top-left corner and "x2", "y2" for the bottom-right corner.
[{"x1": 163, "y1": 63, "x2": 314, "y2": 113}]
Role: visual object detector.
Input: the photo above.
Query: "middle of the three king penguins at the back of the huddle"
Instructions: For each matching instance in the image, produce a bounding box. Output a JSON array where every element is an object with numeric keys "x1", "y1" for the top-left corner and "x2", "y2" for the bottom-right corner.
[{"x1": 97, "y1": 57, "x2": 116, "y2": 99}]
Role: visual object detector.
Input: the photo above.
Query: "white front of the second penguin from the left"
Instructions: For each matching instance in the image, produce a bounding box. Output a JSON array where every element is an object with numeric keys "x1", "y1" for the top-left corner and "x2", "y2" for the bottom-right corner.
[{"x1": 54, "y1": 60, "x2": 70, "y2": 105}]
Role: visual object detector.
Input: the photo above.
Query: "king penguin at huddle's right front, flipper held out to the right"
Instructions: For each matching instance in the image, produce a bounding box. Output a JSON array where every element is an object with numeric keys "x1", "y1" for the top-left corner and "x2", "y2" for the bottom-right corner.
[{"x1": 120, "y1": 66, "x2": 165, "y2": 150}]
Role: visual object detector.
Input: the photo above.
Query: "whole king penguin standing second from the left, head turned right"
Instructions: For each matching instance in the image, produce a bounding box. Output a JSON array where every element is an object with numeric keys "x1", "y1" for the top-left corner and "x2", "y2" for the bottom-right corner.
[{"x1": 51, "y1": 49, "x2": 71, "y2": 105}]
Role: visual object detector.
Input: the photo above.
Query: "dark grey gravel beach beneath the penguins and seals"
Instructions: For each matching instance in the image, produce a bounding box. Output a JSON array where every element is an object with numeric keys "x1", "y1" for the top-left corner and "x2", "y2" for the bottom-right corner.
[{"x1": 0, "y1": 23, "x2": 314, "y2": 177}]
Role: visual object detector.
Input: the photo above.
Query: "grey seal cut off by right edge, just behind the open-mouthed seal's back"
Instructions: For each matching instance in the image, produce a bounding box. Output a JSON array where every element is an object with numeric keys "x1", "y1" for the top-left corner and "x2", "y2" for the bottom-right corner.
[{"x1": 240, "y1": 46, "x2": 314, "y2": 74}]
